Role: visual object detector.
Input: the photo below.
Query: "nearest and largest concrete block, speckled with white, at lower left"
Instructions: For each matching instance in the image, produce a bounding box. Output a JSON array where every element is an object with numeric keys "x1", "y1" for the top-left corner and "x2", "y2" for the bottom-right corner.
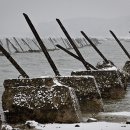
[{"x1": 2, "y1": 78, "x2": 81, "y2": 123}]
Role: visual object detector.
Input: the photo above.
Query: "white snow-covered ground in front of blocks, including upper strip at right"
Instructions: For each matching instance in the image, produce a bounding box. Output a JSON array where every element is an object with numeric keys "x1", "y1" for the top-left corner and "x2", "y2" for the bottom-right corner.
[{"x1": 2, "y1": 111, "x2": 130, "y2": 130}]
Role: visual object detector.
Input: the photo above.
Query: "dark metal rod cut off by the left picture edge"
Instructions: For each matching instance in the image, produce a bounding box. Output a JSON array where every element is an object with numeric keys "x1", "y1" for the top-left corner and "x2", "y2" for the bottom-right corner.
[{"x1": 0, "y1": 45, "x2": 29, "y2": 78}]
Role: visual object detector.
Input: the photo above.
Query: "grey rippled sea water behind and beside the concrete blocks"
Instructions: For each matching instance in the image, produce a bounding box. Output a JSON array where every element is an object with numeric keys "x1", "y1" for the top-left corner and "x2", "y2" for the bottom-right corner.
[{"x1": 0, "y1": 40, "x2": 130, "y2": 117}]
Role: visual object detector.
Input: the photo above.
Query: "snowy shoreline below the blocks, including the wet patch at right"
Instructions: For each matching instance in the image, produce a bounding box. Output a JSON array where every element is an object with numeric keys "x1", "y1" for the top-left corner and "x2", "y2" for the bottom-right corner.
[{"x1": 2, "y1": 111, "x2": 130, "y2": 130}]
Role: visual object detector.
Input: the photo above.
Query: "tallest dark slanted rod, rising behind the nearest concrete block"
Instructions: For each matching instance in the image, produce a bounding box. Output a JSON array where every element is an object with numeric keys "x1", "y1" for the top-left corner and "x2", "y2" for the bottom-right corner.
[{"x1": 23, "y1": 13, "x2": 60, "y2": 76}]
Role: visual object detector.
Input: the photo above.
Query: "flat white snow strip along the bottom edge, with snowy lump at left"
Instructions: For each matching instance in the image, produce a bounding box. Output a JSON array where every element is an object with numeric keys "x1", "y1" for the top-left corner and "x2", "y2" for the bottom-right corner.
[{"x1": 8, "y1": 121, "x2": 130, "y2": 130}]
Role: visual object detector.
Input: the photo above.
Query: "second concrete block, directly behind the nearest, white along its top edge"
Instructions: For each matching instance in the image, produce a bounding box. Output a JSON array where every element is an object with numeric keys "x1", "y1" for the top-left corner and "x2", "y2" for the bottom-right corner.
[{"x1": 56, "y1": 76, "x2": 103, "y2": 113}]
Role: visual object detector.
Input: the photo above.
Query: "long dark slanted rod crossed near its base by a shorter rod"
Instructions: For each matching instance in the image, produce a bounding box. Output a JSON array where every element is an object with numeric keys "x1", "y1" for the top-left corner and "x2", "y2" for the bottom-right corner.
[{"x1": 56, "y1": 19, "x2": 91, "y2": 70}]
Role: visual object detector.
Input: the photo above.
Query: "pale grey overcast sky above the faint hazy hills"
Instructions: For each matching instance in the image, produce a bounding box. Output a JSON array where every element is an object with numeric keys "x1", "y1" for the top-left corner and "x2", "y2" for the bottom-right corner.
[{"x1": 0, "y1": 0, "x2": 130, "y2": 37}]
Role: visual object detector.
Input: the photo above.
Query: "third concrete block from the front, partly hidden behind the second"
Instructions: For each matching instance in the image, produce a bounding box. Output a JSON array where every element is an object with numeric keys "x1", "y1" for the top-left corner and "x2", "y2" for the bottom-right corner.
[{"x1": 71, "y1": 70, "x2": 125, "y2": 99}]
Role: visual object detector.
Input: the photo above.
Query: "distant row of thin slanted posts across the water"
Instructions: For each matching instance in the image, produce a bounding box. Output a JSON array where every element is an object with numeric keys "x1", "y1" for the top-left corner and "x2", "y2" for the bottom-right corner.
[{"x1": 0, "y1": 37, "x2": 99, "y2": 53}]
